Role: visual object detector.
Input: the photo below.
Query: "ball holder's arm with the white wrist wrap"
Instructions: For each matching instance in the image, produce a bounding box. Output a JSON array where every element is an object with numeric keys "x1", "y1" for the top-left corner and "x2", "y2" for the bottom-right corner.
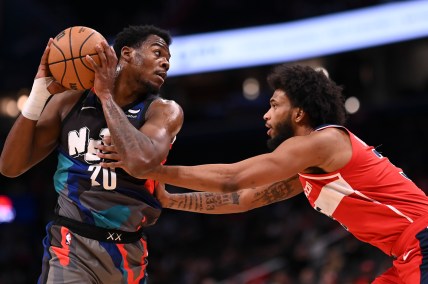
[{"x1": 0, "y1": 39, "x2": 75, "y2": 177}]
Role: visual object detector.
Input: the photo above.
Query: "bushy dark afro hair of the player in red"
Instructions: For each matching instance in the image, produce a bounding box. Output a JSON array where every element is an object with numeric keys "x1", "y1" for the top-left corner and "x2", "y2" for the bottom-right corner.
[{"x1": 267, "y1": 64, "x2": 347, "y2": 128}]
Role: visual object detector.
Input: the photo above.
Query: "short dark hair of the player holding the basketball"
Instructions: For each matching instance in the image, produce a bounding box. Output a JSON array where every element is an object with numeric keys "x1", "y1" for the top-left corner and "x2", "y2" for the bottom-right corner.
[{"x1": 113, "y1": 25, "x2": 172, "y2": 58}]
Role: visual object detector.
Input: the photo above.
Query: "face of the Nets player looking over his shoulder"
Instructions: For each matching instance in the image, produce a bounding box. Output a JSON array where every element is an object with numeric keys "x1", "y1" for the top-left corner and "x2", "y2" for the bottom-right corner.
[{"x1": 132, "y1": 35, "x2": 171, "y2": 93}]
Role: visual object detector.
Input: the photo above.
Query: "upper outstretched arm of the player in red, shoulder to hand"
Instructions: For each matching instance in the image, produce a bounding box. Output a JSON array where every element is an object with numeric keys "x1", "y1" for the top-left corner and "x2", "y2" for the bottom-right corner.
[{"x1": 100, "y1": 116, "x2": 346, "y2": 193}]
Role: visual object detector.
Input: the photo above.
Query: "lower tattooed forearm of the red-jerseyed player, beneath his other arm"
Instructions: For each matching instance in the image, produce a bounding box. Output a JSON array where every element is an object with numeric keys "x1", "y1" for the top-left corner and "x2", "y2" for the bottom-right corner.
[{"x1": 156, "y1": 175, "x2": 303, "y2": 214}]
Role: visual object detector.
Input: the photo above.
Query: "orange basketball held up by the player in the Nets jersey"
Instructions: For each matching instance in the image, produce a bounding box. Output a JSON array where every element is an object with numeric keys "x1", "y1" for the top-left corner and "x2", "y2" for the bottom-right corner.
[{"x1": 48, "y1": 26, "x2": 105, "y2": 90}]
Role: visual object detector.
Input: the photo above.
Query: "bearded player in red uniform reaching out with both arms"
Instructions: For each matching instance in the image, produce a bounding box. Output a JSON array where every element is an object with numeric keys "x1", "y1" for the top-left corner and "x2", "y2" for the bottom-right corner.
[{"x1": 99, "y1": 65, "x2": 428, "y2": 284}]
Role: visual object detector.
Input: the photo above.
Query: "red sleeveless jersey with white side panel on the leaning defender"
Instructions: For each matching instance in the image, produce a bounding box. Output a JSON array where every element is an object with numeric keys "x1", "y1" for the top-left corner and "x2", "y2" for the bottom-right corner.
[{"x1": 299, "y1": 125, "x2": 428, "y2": 255}]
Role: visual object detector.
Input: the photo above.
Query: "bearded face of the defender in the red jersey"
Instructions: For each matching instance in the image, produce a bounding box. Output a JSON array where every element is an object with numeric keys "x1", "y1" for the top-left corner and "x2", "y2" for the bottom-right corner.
[{"x1": 263, "y1": 90, "x2": 294, "y2": 150}]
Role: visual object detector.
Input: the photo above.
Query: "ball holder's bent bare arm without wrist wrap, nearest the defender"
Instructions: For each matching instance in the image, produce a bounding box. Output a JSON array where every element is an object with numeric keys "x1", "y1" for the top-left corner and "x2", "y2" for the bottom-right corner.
[{"x1": 88, "y1": 42, "x2": 183, "y2": 176}]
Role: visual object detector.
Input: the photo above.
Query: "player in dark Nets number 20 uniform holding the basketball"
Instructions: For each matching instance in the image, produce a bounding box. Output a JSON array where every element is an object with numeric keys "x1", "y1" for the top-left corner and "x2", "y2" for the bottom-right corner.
[{"x1": 0, "y1": 25, "x2": 183, "y2": 283}]
